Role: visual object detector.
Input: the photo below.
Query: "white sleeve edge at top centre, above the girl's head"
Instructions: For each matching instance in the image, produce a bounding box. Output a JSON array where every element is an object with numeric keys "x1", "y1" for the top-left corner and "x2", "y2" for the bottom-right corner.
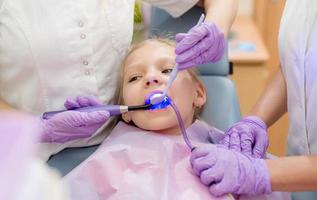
[{"x1": 144, "y1": 0, "x2": 198, "y2": 17}]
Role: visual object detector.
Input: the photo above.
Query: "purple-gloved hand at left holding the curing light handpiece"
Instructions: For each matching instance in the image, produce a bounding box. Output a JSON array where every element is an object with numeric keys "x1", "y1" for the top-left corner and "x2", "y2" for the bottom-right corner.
[{"x1": 40, "y1": 96, "x2": 110, "y2": 143}]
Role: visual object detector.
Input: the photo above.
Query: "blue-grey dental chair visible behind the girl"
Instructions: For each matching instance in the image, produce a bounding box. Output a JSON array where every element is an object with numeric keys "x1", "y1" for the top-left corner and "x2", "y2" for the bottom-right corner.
[{"x1": 48, "y1": 7, "x2": 240, "y2": 176}]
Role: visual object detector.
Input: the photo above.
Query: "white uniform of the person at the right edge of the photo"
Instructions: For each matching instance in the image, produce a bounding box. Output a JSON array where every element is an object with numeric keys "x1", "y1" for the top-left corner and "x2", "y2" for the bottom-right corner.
[{"x1": 279, "y1": 0, "x2": 317, "y2": 155}]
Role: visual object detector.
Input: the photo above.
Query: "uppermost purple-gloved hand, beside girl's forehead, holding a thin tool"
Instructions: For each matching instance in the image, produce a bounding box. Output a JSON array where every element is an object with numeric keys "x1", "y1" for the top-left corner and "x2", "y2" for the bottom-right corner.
[{"x1": 175, "y1": 23, "x2": 225, "y2": 70}]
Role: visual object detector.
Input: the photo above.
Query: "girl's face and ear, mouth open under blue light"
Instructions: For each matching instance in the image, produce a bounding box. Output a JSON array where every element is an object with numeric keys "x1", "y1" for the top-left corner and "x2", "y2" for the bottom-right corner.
[{"x1": 122, "y1": 41, "x2": 206, "y2": 133}]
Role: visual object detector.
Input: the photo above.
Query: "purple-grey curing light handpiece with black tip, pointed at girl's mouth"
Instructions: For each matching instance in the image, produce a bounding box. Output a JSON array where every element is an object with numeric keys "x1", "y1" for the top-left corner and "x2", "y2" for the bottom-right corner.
[{"x1": 42, "y1": 104, "x2": 152, "y2": 119}]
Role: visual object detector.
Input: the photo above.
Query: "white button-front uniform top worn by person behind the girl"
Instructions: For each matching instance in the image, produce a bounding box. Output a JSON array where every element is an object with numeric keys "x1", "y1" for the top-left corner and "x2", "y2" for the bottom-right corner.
[{"x1": 0, "y1": 0, "x2": 198, "y2": 158}]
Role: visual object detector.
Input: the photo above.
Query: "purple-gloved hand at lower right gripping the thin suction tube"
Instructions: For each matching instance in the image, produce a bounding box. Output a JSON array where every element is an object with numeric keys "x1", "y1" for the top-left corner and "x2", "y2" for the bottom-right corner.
[{"x1": 190, "y1": 145, "x2": 272, "y2": 197}]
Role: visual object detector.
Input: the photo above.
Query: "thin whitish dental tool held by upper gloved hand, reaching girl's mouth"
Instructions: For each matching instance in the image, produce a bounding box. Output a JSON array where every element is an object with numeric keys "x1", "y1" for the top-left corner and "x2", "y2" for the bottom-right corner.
[{"x1": 151, "y1": 14, "x2": 205, "y2": 104}]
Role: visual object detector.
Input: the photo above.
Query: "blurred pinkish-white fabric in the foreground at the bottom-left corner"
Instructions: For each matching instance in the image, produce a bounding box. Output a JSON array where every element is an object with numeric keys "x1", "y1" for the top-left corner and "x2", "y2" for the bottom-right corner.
[{"x1": 0, "y1": 112, "x2": 69, "y2": 200}]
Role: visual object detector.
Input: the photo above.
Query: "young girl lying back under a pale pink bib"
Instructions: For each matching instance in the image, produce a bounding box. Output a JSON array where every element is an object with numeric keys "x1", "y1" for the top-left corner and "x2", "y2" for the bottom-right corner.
[{"x1": 65, "y1": 39, "x2": 288, "y2": 200}]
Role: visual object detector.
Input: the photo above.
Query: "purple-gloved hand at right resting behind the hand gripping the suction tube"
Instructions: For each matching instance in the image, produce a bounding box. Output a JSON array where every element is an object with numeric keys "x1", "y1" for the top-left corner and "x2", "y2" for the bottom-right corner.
[{"x1": 219, "y1": 116, "x2": 269, "y2": 158}]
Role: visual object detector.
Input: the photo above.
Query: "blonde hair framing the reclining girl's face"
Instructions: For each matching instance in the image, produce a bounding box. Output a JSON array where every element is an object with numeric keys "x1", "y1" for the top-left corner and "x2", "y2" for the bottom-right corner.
[{"x1": 114, "y1": 38, "x2": 205, "y2": 123}]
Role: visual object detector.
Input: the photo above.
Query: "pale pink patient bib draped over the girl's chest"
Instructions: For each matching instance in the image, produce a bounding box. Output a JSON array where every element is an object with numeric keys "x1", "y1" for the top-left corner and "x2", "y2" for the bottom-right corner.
[{"x1": 65, "y1": 122, "x2": 232, "y2": 200}]
